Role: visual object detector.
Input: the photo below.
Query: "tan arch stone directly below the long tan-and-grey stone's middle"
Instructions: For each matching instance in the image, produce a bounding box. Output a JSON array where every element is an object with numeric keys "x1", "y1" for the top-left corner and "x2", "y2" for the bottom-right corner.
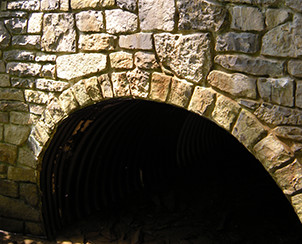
[{"x1": 212, "y1": 95, "x2": 240, "y2": 131}]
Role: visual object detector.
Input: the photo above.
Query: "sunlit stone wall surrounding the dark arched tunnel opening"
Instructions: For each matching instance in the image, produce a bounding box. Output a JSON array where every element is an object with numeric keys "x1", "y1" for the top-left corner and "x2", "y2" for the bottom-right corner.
[{"x1": 0, "y1": 0, "x2": 302, "y2": 234}]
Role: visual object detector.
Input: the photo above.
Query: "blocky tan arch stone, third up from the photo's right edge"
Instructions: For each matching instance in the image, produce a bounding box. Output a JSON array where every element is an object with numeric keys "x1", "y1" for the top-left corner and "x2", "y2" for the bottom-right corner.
[{"x1": 254, "y1": 135, "x2": 293, "y2": 171}]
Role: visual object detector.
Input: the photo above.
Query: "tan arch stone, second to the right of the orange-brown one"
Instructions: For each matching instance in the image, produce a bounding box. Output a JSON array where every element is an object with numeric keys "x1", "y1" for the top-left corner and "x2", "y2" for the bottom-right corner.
[{"x1": 188, "y1": 86, "x2": 216, "y2": 115}]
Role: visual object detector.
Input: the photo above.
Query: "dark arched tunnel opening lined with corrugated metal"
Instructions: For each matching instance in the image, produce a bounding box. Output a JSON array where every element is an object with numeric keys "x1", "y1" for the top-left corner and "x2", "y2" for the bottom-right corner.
[{"x1": 40, "y1": 99, "x2": 302, "y2": 243}]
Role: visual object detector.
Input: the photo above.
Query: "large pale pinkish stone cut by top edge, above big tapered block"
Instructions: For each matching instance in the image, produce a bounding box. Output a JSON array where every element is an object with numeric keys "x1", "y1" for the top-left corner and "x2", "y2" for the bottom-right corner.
[{"x1": 138, "y1": 0, "x2": 175, "y2": 31}]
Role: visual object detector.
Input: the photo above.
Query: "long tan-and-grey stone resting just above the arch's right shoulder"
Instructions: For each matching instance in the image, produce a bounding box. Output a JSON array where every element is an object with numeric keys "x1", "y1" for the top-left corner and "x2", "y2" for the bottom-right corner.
[{"x1": 208, "y1": 70, "x2": 257, "y2": 99}]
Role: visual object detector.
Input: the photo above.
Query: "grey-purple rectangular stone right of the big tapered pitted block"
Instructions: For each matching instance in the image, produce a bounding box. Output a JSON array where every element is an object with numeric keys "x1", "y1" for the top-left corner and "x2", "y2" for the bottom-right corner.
[{"x1": 215, "y1": 32, "x2": 260, "y2": 53}]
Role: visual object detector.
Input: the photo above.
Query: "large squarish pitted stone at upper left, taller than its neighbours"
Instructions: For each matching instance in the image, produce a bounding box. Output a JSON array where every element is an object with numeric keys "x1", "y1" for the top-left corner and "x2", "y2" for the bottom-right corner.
[{"x1": 41, "y1": 13, "x2": 76, "y2": 52}]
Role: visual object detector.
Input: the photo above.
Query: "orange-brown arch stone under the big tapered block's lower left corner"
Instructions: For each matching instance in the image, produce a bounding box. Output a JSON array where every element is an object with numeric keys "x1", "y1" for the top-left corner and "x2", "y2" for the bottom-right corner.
[{"x1": 150, "y1": 72, "x2": 172, "y2": 102}]
